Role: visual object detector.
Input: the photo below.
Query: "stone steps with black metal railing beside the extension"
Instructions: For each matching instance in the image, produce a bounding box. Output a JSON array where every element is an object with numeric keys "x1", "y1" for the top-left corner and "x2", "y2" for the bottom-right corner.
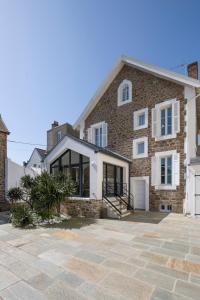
[{"x1": 103, "y1": 196, "x2": 130, "y2": 219}]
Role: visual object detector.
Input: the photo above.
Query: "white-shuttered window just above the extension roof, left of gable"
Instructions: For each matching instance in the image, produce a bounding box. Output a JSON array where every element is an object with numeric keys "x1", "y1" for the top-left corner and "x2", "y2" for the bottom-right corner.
[{"x1": 88, "y1": 122, "x2": 107, "y2": 147}]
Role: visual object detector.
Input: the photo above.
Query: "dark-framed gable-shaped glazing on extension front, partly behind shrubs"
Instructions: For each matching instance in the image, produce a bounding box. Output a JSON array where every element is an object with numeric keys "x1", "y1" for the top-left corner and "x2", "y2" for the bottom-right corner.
[{"x1": 50, "y1": 150, "x2": 90, "y2": 197}]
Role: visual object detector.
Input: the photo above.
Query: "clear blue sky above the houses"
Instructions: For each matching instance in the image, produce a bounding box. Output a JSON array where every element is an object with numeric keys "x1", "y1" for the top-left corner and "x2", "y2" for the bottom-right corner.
[{"x1": 0, "y1": 0, "x2": 200, "y2": 163}]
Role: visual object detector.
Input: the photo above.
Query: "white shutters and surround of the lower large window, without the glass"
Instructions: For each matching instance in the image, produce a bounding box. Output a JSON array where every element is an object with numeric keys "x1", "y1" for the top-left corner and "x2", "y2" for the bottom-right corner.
[{"x1": 151, "y1": 150, "x2": 180, "y2": 190}]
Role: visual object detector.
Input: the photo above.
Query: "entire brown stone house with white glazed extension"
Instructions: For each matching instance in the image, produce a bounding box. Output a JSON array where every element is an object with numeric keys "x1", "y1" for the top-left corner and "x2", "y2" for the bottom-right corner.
[{"x1": 45, "y1": 56, "x2": 200, "y2": 216}]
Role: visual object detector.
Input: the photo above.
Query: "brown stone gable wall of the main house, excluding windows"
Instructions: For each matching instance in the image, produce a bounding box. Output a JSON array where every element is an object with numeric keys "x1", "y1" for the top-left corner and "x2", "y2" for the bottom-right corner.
[{"x1": 85, "y1": 66, "x2": 185, "y2": 213}]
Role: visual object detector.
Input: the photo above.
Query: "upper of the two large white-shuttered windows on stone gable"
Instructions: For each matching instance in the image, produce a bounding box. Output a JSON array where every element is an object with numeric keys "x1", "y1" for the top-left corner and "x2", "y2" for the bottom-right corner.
[{"x1": 152, "y1": 99, "x2": 180, "y2": 141}]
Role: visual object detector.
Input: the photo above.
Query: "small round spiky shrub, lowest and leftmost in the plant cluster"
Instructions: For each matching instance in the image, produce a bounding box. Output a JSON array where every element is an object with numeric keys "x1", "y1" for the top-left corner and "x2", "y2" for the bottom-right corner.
[{"x1": 11, "y1": 204, "x2": 34, "y2": 227}]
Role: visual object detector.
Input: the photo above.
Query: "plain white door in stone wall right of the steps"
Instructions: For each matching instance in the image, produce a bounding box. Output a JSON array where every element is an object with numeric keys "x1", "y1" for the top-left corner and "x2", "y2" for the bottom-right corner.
[{"x1": 131, "y1": 178, "x2": 146, "y2": 209}]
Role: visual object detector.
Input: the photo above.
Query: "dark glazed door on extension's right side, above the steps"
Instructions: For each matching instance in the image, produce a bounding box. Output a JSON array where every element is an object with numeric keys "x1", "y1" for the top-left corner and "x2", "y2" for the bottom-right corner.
[{"x1": 103, "y1": 163, "x2": 123, "y2": 196}]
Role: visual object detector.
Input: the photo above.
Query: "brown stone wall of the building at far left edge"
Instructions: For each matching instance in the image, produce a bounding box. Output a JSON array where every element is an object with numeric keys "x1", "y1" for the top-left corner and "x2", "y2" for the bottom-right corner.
[{"x1": 0, "y1": 131, "x2": 7, "y2": 211}]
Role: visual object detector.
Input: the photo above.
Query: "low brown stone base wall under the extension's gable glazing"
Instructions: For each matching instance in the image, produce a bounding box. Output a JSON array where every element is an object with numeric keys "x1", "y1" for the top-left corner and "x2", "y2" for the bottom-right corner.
[{"x1": 61, "y1": 199, "x2": 103, "y2": 218}]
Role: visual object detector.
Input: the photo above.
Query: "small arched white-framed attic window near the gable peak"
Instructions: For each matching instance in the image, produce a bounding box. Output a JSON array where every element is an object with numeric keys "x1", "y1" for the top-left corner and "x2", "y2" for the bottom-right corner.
[{"x1": 118, "y1": 79, "x2": 132, "y2": 106}]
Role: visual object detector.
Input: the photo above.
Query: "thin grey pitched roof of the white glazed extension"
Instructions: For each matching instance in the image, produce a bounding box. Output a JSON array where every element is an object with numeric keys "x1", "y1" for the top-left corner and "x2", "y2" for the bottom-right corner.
[{"x1": 45, "y1": 133, "x2": 131, "y2": 163}]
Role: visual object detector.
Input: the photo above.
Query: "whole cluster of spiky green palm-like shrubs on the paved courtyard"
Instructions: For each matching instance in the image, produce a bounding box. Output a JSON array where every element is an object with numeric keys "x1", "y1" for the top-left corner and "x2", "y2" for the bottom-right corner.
[{"x1": 8, "y1": 172, "x2": 75, "y2": 226}]
